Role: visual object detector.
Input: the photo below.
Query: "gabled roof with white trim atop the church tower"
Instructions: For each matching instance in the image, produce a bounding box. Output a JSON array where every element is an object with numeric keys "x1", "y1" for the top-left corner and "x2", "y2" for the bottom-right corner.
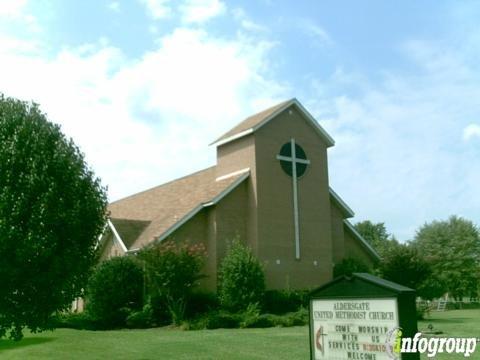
[{"x1": 210, "y1": 98, "x2": 335, "y2": 147}]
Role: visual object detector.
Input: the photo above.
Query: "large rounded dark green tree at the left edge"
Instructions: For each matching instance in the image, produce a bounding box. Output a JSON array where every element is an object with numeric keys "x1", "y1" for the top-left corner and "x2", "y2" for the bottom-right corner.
[{"x1": 0, "y1": 95, "x2": 107, "y2": 340}]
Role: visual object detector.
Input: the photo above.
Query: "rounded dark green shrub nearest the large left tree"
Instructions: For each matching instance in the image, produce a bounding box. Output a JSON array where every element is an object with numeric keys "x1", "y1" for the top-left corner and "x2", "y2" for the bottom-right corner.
[{"x1": 86, "y1": 256, "x2": 143, "y2": 328}]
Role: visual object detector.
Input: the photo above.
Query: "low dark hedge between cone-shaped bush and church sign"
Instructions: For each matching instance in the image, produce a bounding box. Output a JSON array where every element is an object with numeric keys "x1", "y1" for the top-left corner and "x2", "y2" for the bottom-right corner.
[{"x1": 263, "y1": 290, "x2": 309, "y2": 314}]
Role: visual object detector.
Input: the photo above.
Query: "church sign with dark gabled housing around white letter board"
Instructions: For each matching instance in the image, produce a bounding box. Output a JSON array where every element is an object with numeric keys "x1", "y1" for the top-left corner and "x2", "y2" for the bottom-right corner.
[{"x1": 310, "y1": 273, "x2": 419, "y2": 360}]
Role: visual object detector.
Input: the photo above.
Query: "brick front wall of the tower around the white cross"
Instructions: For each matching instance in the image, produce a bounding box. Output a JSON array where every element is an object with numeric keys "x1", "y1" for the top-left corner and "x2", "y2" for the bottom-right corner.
[{"x1": 255, "y1": 105, "x2": 332, "y2": 288}]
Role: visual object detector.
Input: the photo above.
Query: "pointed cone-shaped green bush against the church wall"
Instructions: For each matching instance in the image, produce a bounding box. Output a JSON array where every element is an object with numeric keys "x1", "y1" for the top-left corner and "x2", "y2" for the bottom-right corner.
[{"x1": 218, "y1": 240, "x2": 265, "y2": 311}]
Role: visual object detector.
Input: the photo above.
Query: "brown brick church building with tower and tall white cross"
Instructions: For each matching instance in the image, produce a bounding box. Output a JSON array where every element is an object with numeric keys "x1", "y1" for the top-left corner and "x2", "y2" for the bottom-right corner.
[{"x1": 100, "y1": 99, "x2": 378, "y2": 290}]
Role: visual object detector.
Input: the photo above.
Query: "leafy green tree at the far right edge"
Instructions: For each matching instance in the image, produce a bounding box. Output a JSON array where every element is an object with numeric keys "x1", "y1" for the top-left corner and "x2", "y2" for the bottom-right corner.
[{"x1": 412, "y1": 216, "x2": 480, "y2": 298}]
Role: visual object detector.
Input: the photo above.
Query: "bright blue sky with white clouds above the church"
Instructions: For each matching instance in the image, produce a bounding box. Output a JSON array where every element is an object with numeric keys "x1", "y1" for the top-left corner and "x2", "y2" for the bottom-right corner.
[{"x1": 0, "y1": 0, "x2": 480, "y2": 241}]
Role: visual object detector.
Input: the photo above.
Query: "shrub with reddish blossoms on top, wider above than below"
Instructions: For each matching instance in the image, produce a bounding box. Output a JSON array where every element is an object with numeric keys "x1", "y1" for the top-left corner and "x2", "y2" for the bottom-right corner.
[{"x1": 139, "y1": 241, "x2": 205, "y2": 325}]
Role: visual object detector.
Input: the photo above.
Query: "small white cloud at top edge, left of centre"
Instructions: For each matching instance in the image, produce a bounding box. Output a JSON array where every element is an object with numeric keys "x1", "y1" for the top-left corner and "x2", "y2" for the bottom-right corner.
[{"x1": 179, "y1": 0, "x2": 226, "y2": 23}]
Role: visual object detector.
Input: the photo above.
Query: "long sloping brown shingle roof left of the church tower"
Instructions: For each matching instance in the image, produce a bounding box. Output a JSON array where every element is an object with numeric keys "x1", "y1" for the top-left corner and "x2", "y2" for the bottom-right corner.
[{"x1": 108, "y1": 166, "x2": 245, "y2": 250}]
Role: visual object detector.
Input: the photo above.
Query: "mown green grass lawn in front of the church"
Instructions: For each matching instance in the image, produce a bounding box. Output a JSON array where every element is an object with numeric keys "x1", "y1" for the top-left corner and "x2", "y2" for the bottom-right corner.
[{"x1": 0, "y1": 310, "x2": 480, "y2": 360}]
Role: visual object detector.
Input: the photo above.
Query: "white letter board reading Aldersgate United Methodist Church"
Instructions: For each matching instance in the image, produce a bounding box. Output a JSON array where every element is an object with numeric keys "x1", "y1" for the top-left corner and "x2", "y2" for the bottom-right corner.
[{"x1": 310, "y1": 299, "x2": 399, "y2": 360}]
